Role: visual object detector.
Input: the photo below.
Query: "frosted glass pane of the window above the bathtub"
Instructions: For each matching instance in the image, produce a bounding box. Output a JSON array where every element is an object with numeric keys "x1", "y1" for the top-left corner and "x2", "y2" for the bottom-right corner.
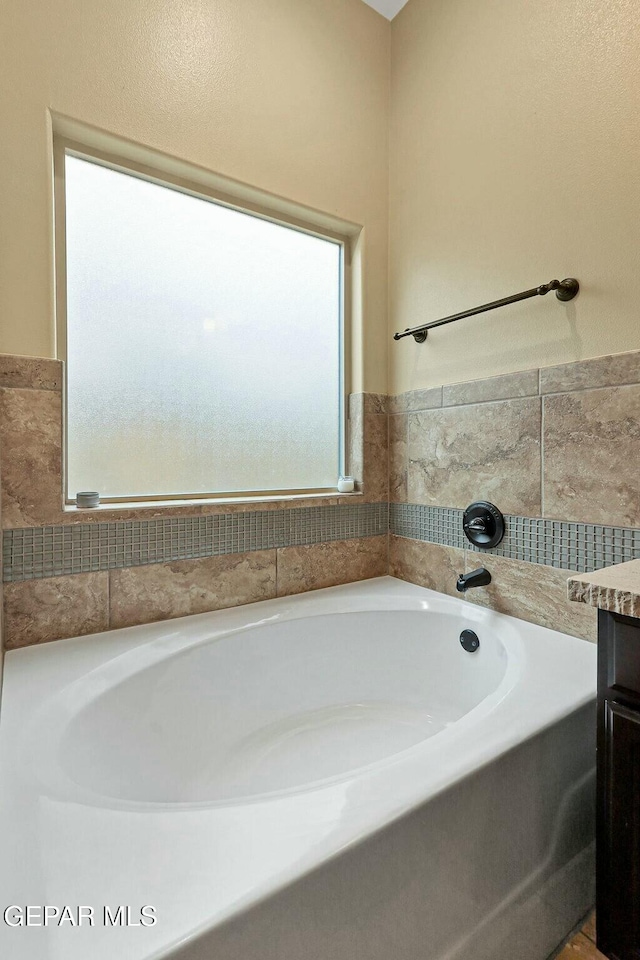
[{"x1": 65, "y1": 154, "x2": 342, "y2": 498}]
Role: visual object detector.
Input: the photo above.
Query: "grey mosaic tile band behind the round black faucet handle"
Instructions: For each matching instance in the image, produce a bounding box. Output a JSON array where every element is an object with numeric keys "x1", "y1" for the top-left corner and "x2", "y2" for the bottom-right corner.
[{"x1": 389, "y1": 503, "x2": 640, "y2": 573}]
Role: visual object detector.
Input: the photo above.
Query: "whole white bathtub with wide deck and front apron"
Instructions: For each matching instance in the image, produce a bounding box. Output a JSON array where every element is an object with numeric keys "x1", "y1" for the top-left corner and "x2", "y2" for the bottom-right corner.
[{"x1": 0, "y1": 577, "x2": 596, "y2": 960}]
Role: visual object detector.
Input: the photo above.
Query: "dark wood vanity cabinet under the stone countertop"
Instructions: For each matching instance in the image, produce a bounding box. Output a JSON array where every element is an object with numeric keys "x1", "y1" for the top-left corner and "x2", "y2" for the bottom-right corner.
[{"x1": 596, "y1": 610, "x2": 640, "y2": 960}]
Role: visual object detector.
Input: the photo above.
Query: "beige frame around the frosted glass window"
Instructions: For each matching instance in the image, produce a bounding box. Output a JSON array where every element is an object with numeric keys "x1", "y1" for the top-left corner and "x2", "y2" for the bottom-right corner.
[{"x1": 53, "y1": 140, "x2": 354, "y2": 507}]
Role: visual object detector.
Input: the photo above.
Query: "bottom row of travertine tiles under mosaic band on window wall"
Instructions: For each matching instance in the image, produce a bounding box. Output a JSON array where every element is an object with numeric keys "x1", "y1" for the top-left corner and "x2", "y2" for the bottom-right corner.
[{"x1": 4, "y1": 531, "x2": 388, "y2": 650}]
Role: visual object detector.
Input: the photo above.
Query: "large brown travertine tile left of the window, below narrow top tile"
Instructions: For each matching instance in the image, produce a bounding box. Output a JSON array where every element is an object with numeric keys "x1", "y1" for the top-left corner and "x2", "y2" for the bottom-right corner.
[{"x1": 0, "y1": 388, "x2": 62, "y2": 528}]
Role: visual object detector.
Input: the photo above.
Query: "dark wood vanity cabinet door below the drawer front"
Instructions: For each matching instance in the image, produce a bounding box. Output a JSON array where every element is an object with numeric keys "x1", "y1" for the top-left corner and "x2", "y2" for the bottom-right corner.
[{"x1": 597, "y1": 700, "x2": 640, "y2": 960}]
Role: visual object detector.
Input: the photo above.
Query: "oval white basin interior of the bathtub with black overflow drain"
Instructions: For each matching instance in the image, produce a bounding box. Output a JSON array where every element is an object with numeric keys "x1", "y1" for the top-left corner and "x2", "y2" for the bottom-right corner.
[{"x1": 47, "y1": 610, "x2": 508, "y2": 803}]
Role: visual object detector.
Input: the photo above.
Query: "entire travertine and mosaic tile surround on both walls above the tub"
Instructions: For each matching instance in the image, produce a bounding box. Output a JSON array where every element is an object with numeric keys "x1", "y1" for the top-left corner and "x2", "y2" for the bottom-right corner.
[{"x1": 0, "y1": 348, "x2": 640, "y2": 644}]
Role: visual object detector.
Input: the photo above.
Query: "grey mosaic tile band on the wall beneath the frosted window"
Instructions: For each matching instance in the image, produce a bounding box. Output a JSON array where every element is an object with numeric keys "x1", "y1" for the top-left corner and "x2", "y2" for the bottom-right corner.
[{"x1": 2, "y1": 503, "x2": 389, "y2": 583}]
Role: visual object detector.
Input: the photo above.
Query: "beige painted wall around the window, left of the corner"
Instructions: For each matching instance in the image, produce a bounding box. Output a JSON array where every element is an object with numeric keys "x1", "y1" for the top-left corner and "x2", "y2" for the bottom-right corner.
[{"x1": 0, "y1": 0, "x2": 389, "y2": 392}]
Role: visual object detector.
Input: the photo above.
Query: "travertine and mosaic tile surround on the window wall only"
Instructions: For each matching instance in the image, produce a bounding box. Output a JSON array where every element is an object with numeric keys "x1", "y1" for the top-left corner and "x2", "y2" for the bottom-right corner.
[{"x1": 0, "y1": 356, "x2": 388, "y2": 646}]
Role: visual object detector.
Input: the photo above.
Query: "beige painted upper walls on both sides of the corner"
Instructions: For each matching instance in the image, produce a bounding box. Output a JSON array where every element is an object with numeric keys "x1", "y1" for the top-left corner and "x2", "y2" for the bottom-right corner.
[{"x1": 5, "y1": 0, "x2": 640, "y2": 392}]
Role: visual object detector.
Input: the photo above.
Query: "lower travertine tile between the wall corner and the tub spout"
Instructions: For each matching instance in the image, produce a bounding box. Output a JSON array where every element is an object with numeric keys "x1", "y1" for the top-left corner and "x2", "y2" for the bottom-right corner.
[{"x1": 389, "y1": 536, "x2": 464, "y2": 597}]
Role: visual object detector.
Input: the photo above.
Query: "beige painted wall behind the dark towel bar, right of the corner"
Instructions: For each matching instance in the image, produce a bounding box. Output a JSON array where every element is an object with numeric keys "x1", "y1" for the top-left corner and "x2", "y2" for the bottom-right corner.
[{"x1": 390, "y1": 0, "x2": 640, "y2": 393}]
